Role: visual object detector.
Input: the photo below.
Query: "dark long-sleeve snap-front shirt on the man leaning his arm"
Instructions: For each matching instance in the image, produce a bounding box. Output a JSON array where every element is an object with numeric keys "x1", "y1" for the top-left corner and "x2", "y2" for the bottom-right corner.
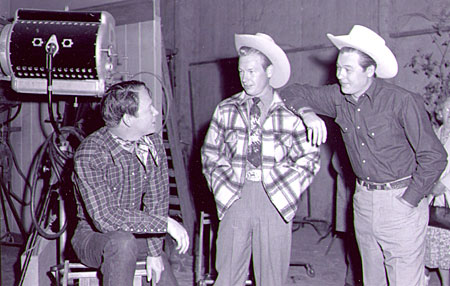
[{"x1": 280, "y1": 79, "x2": 447, "y2": 206}]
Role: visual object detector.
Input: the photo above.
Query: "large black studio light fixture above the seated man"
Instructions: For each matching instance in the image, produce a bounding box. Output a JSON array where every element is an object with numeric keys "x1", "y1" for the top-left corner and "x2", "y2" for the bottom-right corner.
[{"x1": 0, "y1": 9, "x2": 116, "y2": 96}]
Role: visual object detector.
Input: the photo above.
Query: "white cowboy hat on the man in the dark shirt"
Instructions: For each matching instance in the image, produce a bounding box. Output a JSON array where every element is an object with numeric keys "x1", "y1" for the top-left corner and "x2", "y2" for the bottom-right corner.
[{"x1": 327, "y1": 25, "x2": 398, "y2": 78}]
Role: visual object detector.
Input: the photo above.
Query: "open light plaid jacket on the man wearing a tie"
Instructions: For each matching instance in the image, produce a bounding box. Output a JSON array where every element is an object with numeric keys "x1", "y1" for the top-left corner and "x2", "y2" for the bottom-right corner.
[{"x1": 202, "y1": 92, "x2": 320, "y2": 221}]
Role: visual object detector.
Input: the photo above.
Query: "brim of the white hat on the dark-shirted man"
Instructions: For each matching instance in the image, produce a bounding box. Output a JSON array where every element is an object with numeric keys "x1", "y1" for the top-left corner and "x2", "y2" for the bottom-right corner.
[{"x1": 327, "y1": 34, "x2": 398, "y2": 78}]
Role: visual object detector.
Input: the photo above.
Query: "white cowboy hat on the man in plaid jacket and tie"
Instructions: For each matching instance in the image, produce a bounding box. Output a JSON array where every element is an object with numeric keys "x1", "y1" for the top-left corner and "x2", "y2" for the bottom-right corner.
[{"x1": 234, "y1": 33, "x2": 291, "y2": 88}]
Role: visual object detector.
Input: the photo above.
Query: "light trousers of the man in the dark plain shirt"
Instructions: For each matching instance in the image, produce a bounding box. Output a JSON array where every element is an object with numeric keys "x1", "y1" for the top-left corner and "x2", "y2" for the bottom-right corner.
[{"x1": 353, "y1": 184, "x2": 428, "y2": 286}]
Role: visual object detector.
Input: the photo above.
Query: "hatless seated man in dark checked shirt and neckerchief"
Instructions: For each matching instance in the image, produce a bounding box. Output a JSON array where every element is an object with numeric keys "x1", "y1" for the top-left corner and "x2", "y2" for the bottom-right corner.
[{"x1": 72, "y1": 81, "x2": 189, "y2": 286}]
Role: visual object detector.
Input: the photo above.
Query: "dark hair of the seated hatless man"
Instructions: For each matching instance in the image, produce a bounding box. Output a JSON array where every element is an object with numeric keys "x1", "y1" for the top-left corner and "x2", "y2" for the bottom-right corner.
[{"x1": 101, "y1": 80, "x2": 151, "y2": 127}]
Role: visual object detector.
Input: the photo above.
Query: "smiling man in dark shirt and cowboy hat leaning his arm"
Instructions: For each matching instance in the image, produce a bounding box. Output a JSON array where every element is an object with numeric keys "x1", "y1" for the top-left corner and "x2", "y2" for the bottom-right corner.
[{"x1": 280, "y1": 25, "x2": 446, "y2": 286}]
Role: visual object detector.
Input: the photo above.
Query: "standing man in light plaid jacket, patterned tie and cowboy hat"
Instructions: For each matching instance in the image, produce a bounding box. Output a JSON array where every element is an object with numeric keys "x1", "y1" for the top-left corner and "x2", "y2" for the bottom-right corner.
[{"x1": 202, "y1": 33, "x2": 319, "y2": 286}]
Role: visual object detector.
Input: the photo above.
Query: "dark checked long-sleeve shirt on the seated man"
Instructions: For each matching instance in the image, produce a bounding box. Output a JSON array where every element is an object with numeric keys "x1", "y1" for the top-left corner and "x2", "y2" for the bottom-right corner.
[{"x1": 74, "y1": 127, "x2": 169, "y2": 256}]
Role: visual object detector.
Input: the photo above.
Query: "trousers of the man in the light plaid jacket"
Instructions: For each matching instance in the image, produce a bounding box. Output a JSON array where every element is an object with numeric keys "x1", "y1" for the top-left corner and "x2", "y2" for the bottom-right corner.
[{"x1": 214, "y1": 181, "x2": 292, "y2": 286}]
